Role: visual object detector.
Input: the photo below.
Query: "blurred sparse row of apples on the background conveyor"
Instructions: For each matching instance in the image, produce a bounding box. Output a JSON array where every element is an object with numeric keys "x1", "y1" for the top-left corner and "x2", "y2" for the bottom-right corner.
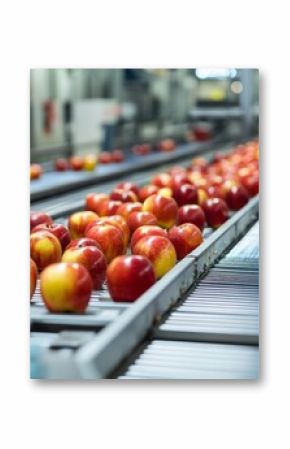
[{"x1": 30, "y1": 139, "x2": 176, "y2": 180}]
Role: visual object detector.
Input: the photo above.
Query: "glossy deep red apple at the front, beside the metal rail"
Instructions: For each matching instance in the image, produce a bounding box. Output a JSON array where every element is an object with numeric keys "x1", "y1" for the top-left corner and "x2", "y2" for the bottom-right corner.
[{"x1": 107, "y1": 255, "x2": 156, "y2": 302}]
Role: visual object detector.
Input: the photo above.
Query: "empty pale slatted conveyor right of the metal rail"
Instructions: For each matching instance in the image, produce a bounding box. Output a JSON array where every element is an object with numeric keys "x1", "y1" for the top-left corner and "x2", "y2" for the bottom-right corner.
[{"x1": 118, "y1": 223, "x2": 259, "y2": 379}]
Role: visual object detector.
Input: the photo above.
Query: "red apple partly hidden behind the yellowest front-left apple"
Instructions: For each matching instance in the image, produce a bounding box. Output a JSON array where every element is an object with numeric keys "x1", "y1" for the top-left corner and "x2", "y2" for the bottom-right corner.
[{"x1": 61, "y1": 246, "x2": 107, "y2": 290}]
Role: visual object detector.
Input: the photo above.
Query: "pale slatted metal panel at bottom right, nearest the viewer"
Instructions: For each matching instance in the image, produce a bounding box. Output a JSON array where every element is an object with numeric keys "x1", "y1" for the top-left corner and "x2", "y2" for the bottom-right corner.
[{"x1": 118, "y1": 339, "x2": 259, "y2": 380}]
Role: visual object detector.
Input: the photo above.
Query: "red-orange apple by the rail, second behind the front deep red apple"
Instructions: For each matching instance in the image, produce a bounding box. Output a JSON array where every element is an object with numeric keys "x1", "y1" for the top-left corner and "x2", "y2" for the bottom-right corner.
[{"x1": 168, "y1": 223, "x2": 203, "y2": 260}]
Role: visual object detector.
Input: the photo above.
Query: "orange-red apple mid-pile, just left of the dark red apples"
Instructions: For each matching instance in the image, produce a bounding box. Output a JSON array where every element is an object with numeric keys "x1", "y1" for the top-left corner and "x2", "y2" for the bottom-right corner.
[{"x1": 143, "y1": 194, "x2": 178, "y2": 229}]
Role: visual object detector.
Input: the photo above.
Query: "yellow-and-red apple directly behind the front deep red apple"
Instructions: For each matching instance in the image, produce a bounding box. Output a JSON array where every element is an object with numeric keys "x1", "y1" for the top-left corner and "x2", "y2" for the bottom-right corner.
[{"x1": 133, "y1": 235, "x2": 177, "y2": 279}]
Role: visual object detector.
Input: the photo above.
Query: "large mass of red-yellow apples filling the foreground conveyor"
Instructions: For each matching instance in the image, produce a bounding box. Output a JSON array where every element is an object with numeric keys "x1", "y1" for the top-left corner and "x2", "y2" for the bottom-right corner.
[{"x1": 30, "y1": 138, "x2": 259, "y2": 311}]
